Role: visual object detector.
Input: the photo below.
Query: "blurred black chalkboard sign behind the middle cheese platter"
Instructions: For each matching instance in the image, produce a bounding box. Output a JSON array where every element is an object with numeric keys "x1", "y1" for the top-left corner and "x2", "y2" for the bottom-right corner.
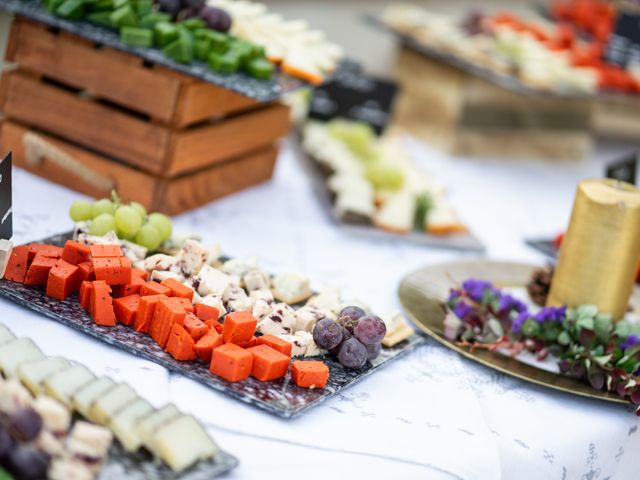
[{"x1": 309, "y1": 66, "x2": 398, "y2": 135}]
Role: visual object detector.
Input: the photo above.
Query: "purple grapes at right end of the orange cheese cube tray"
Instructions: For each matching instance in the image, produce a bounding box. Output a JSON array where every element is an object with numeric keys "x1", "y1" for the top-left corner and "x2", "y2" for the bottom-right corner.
[{"x1": 313, "y1": 306, "x2": 387, "y2": 370}]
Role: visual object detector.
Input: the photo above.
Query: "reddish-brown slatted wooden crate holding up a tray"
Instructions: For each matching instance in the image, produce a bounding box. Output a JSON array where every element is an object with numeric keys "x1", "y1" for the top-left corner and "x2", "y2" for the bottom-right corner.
[{"x1": 0, "y1": 18, "x2": 289, "y2": 213}]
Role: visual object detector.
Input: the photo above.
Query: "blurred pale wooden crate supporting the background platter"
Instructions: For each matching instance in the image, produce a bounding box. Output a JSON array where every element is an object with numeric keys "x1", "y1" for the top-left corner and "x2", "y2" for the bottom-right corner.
[{"x1": 395, "y1": 48, "x2": 593, "y2": 160}]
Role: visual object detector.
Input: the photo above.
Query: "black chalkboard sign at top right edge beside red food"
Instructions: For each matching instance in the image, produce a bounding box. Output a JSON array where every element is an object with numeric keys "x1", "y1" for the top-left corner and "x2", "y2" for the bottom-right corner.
[{"x1": 606, "y1": 11, "x2": 640, "y2": 68}]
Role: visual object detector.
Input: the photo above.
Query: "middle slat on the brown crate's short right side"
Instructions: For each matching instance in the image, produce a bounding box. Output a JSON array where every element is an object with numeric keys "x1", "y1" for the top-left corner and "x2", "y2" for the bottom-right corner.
[{"x1": 167, "y1": 104, "x2": 289, "y2": 175}]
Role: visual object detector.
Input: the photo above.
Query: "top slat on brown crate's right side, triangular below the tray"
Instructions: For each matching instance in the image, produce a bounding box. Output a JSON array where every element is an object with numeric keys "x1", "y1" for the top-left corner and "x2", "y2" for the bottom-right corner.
[{"x1": 173, "y1": 82, "x2": 260, "y2": 127}]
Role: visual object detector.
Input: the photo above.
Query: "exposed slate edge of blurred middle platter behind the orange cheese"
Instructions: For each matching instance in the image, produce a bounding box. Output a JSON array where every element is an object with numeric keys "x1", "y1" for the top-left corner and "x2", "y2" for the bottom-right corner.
[{"x1": 298, "y1": 135, "x2": 486, "y2": 253}]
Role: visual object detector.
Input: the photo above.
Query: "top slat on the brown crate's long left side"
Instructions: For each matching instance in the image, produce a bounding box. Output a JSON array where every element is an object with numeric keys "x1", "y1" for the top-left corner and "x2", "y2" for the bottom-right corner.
[{"x1": 12, "y1": 21, "x2": 180, "y2": 122}]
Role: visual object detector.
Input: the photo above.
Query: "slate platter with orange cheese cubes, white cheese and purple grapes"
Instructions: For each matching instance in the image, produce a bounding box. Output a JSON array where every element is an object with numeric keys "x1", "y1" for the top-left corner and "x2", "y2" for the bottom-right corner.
[{"x1": 0, "y1": 216, "x2": 424, "y2": 418}]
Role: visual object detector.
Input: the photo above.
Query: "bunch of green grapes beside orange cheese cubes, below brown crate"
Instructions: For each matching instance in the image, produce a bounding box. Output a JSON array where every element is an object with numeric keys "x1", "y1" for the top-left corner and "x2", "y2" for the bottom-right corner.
[{"x1": 69, "y1": 194, "x2": 173, "y2": 251}]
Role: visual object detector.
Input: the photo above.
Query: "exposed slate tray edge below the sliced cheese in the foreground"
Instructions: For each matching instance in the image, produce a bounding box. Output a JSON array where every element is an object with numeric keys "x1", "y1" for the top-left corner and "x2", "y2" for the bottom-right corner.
[{"x1": 98, "y1": 441, "x2": 238, "y2": 480}]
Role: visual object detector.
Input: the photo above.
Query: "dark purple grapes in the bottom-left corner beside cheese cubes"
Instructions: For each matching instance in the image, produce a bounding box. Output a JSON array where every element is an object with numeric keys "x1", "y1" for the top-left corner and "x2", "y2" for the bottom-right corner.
[{"x1": 0, "y1": 408, "x2": 50, "y2": 480}]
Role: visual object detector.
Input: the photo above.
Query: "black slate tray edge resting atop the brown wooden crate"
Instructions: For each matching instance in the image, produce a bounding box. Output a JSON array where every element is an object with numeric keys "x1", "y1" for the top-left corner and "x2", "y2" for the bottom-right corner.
[{"x1": 0, "y1": 0, "x2": 308, "y2": 102}]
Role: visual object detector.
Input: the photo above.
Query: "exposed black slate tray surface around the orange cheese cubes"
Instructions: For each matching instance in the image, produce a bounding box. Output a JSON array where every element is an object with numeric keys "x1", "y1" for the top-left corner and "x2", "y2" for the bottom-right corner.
[{"x1": 0, "y1": 233, "x2": 424, "y2": 418}]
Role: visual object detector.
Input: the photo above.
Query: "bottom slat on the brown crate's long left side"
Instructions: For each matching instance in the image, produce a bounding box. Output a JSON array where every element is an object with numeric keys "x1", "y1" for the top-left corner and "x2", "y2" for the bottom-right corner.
[{"x1": 0, "y1": 120, "x2": 157, "y2": 208}]
